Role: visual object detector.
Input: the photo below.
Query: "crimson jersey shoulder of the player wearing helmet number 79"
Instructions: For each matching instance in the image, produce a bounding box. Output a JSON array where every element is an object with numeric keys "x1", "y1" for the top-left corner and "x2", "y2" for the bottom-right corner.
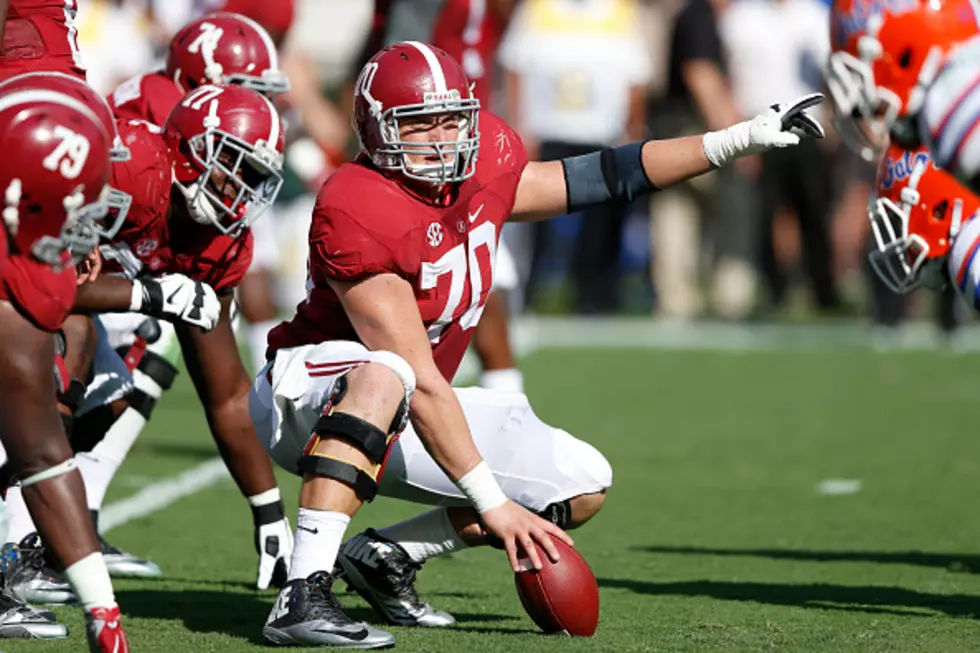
[{"x1": 0, "y1": 253, "x2": 78, "y2": 333}]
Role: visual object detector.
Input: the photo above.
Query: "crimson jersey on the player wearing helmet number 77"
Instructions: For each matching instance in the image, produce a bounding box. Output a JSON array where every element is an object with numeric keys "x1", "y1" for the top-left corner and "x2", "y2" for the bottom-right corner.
[{"x1": 103, "y1": 120, "x2": 253, "y2": 292}]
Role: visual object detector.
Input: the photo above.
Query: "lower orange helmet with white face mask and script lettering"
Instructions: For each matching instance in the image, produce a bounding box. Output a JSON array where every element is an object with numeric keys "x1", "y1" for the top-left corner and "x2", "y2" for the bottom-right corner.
[{"x1": 868, "y1": 146, "x2": 980, "y2": 293}]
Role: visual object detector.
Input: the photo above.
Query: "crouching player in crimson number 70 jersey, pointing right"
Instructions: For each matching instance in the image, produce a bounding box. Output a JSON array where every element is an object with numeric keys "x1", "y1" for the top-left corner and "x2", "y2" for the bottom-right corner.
[{"x1": 249, "y1": 42, "x2": 823, "y2": 648}]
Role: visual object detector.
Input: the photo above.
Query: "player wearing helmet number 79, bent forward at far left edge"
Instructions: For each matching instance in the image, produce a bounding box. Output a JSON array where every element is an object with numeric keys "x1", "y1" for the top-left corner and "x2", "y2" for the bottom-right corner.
[{"x1": 0, "y1": 90, "x2": 128, "y2": 652}]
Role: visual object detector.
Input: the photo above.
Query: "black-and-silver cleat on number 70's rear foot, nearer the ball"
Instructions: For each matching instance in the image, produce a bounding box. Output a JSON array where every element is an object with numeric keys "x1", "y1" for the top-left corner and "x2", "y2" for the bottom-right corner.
[{"x1": 337, "y1": 528, "x2": 456, "y2": 628}]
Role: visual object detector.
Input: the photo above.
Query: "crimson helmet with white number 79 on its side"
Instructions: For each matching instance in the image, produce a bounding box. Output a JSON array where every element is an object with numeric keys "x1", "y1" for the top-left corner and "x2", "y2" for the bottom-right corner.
[{"x1": 0, "y1": 89, "x2": 112, "y2": 268}]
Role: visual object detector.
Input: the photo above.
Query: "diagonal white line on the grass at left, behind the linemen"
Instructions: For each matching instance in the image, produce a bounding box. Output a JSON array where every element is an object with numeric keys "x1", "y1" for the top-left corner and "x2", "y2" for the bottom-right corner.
[{"x1": 99, "y1": 456, "x2": 230, "y2": 533}]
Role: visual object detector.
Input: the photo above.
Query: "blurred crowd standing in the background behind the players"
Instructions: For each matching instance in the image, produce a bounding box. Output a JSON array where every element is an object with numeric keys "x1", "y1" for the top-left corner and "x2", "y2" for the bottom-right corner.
[{"x1": 78, "y1": 0, "x2": 963, "y2": 332}]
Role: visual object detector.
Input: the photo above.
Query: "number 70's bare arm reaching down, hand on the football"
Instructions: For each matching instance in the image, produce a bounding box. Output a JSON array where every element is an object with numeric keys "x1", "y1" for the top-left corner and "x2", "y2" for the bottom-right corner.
[{"x1": 330, "y1": 274, "x2": 571, "y2": 570}]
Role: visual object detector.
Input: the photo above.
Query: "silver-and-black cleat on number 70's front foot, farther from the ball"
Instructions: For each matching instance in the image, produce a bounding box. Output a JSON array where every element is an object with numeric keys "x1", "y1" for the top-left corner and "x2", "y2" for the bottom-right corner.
[{"x1": 262, "y1": 571, "x2": 395, "y2": 649}]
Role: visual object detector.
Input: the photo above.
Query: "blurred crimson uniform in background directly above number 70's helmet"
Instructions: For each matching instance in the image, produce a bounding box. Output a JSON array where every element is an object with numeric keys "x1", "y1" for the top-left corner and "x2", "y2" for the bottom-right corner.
[{"x1": 432, "y1": 0, "x2": 503, "y2": 109}]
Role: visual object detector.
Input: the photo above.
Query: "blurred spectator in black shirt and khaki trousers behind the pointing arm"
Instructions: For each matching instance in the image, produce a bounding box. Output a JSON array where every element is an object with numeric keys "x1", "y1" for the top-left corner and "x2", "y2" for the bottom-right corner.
[{"x1": 651, "y1": 0, "x2": 759, "y2": 318}]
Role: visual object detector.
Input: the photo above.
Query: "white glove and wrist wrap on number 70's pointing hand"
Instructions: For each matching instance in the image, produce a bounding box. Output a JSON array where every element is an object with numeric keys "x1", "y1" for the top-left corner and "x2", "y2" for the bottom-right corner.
[{"x1": 703, "y1": 93, "x2": 824, "y2": 168}]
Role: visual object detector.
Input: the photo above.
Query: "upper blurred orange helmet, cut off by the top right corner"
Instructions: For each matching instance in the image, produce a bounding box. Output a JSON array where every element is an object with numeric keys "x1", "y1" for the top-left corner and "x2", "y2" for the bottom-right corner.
[{"x1": 825, "y1": 0, "x2": 980, "y2": 161}]
